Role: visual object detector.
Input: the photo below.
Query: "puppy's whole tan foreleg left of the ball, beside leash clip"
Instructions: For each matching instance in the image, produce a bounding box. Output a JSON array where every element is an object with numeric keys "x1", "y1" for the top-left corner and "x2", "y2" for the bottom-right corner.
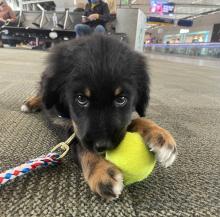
[{"x1": 78, "y1": 147, "x2": 123, "y2": 200}]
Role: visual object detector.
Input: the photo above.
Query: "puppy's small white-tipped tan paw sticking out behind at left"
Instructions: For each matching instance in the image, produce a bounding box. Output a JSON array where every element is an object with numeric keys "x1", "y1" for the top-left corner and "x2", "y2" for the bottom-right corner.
[{"x1": 21, "y1": 95, "x2": 42, "y2": 113}]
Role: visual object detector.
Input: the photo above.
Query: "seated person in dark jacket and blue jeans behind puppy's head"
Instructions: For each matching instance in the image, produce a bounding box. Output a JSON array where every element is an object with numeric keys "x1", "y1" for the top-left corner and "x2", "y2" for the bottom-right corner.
[{"x1": 74, "y1": 0, "x2": 110, "y2": 37}]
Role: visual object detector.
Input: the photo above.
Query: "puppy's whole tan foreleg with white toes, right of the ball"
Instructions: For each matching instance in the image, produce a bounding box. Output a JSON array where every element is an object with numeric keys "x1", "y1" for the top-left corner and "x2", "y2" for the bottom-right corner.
[{"x1": 128, "y1": 118, "x2": 177, "y2": 167}]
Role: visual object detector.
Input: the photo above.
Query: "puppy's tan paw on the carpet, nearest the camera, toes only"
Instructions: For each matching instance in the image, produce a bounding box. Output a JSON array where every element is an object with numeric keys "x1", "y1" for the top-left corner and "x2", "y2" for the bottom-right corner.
[{"x1": 87, "y1": 159, "x2": 123, "y2": 200}]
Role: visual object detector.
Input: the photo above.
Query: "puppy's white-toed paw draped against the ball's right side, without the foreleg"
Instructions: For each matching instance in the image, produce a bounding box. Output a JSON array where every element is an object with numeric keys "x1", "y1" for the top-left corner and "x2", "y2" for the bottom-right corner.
[{"x1": 148, "y1": 128, "x2": 177, "y2": 167}]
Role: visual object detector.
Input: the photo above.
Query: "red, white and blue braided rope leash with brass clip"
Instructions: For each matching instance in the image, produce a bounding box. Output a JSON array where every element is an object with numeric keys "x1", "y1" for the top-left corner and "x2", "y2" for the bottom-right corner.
[{"x1": 0, "y1": 134, "x2": 75, "y2": 187}]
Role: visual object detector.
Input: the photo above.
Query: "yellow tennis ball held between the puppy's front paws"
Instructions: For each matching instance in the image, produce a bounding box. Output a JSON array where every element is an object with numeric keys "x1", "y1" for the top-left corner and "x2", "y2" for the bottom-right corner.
[{"x1": 106, "y1": 132, "x2": 156, "y2": 185}]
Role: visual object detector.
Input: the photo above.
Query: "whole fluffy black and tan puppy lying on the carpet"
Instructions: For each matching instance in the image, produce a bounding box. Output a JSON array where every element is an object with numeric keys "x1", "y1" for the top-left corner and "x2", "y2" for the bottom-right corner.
[{"x1": 21, "y1": 35, "x2": 176, "y2": 199}]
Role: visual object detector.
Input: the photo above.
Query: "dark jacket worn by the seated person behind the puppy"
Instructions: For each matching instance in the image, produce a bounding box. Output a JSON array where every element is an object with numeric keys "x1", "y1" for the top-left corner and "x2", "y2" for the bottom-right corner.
[{"x1": 84, "y1": 0, "x2": 110, "y2": 27}]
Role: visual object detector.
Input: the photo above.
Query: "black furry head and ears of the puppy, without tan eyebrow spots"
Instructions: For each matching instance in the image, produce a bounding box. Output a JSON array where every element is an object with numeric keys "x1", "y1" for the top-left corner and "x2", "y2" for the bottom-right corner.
[{"x1": 40, "y1": 35, "x2": 149, "y2": 152}]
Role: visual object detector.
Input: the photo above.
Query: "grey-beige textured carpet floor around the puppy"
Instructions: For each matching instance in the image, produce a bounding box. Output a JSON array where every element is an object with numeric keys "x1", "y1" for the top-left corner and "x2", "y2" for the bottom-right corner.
[{"x1": 0, "y1": 49, "x2": 220, "y2": 217}]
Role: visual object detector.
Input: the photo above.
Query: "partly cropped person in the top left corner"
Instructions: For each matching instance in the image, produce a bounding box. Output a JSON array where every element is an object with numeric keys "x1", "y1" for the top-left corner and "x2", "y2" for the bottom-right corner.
[{"x1": 0, "y1": 0, "x2": 16, "y2": 26}]
